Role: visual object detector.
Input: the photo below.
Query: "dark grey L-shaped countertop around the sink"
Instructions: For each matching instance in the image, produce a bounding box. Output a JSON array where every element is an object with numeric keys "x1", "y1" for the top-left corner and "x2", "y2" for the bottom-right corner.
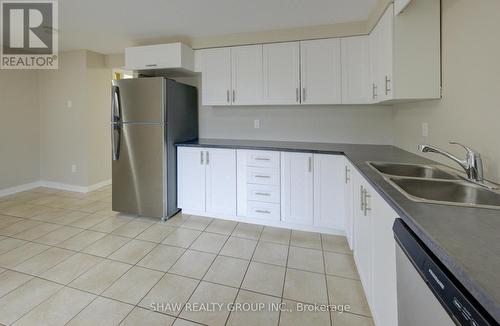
[{"x1": 176, "y1": 139, "x2": 500, "y2": 323}]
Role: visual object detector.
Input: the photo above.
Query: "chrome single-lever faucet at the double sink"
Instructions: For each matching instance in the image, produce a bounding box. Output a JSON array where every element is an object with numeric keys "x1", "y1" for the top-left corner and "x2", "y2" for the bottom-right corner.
[{"x1": 418, "y1": 141, "x2": 484, "y2": 183}]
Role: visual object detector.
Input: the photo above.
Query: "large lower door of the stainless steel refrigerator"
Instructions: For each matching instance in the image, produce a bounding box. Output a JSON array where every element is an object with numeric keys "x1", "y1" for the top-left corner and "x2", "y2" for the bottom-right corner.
[{"x1": 112, "y1": 124, "x2": 166, "y2": 218}]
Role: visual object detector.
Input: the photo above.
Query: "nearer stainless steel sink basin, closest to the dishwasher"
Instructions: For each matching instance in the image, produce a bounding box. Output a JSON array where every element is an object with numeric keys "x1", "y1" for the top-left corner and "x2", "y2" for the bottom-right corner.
[{"x1": 388, "y1": 177, "x2": 500, "y2": 209}]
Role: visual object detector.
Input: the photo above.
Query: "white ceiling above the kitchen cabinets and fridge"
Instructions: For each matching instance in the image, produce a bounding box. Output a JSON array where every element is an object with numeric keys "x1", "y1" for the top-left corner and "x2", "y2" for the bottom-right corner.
[{"x1": 59, "y1": 0, "x2": 377, "y2": 53}]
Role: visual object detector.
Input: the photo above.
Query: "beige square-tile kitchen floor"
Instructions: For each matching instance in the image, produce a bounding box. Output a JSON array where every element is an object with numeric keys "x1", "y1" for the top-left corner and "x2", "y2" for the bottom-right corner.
[{"x1": 0, "y1": 187, "x2": 373, "y2": 326}]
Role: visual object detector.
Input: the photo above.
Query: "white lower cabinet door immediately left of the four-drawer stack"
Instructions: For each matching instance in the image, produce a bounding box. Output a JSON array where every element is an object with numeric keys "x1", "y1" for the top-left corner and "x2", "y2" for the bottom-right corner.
[{"x1": 206, "y1": 148, "x2": 236, "y2": 216}]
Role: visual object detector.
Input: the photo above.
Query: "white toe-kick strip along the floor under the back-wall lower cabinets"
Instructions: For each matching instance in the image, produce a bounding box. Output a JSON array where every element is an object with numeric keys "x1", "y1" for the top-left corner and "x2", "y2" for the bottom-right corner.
[{"x1": 182, "y1": 209, "x2": 346, "y2": 236}]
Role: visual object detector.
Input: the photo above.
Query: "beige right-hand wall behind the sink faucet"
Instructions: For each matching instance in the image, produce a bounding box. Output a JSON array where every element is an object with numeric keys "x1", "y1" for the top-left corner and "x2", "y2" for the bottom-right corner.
[{"x1": 394, "y1": 0, "x2": 500, "y2": 181}]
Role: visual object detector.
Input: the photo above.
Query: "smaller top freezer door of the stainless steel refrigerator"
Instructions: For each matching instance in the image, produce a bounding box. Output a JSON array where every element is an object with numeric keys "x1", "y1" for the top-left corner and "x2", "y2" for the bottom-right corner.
[{"x1": 112, "y1": 77, "x2": 165, "y2": 123}]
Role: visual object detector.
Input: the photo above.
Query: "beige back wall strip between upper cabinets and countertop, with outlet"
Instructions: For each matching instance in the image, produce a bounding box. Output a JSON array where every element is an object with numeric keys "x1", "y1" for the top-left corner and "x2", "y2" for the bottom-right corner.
[{"x1": 199, "y1": 106, "x2": 393, "y2": 144}]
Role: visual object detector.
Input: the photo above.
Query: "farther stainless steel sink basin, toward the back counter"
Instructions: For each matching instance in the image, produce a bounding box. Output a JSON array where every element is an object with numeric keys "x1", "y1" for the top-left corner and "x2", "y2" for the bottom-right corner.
[{"x1": 369, "y1": 162, "x2": 459, "y2": 180}]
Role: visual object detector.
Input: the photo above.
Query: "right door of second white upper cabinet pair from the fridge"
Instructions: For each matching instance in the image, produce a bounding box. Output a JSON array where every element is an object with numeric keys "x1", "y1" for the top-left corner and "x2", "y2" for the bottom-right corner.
[{"x1": 300, "y1": 38, "x2": 342, "y2": 104}]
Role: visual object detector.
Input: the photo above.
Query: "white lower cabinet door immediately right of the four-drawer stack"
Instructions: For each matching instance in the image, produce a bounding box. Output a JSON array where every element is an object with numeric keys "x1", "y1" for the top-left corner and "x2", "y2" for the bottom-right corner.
[{"x1": 281, "y1": 152, "x2": 313, "y2": 225}]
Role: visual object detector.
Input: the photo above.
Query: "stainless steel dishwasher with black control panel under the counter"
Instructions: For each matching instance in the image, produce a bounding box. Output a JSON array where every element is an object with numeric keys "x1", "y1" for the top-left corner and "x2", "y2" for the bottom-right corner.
[{"x1": 393, "y1": 219, "x2": 498, "y2": 326}]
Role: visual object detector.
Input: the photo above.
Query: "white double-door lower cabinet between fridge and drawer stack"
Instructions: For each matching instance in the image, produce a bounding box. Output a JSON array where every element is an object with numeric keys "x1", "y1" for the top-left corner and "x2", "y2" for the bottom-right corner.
[{"x1": 177, "y1": 147, "x2": 236, "y2": 216}]
